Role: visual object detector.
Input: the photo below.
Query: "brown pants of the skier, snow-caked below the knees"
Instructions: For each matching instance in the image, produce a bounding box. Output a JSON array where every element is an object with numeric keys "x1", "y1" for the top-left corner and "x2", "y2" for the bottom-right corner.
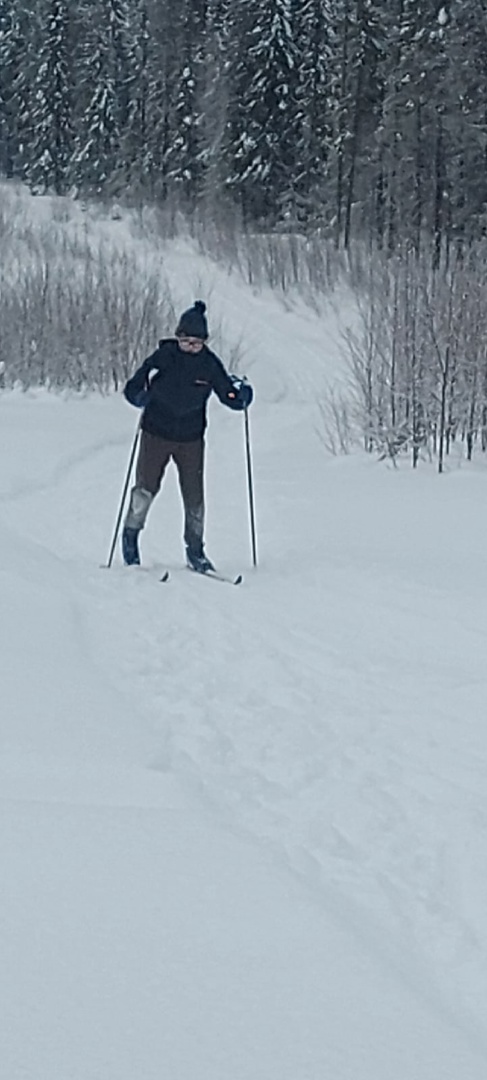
[{"x1": 128, "y1": 431, "x2": 204, "y2": 552}]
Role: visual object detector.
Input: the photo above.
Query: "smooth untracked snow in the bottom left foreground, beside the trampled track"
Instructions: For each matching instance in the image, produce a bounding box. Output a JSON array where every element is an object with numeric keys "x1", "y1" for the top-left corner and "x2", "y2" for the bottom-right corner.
[{"x1": 0, "y1": 798, "x2": 483, "y2": 1080}]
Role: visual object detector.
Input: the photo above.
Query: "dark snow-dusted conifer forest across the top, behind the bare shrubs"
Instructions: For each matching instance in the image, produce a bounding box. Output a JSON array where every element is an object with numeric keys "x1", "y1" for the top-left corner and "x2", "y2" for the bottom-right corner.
[{"x1": 0, "y1": 0, "x2": 487, "y2": 252}]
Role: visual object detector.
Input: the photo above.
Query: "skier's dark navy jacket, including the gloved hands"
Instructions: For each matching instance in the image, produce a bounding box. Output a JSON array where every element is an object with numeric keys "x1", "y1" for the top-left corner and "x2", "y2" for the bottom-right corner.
[{"x1": 123, "y1": 338, "x2": 252, "y2": 443}]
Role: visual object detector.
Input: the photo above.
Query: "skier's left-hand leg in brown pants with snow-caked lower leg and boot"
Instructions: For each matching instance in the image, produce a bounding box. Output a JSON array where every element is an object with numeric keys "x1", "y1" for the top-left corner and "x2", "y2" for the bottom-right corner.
[{"x1": 122, "y1": 431, "x2": 173, "y2": 564}]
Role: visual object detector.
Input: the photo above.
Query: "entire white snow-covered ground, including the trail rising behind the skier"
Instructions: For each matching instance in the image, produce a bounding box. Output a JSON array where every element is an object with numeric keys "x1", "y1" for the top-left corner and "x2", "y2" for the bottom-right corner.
[{"x1": 0, "y1": 190, "x2": 487, "y2": 1080}]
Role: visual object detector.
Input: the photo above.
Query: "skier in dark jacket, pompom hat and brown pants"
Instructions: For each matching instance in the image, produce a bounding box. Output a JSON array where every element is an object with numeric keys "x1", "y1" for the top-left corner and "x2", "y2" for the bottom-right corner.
[{"x1": 122, "y1": 300, "x2": 254, "y2": 573}]
